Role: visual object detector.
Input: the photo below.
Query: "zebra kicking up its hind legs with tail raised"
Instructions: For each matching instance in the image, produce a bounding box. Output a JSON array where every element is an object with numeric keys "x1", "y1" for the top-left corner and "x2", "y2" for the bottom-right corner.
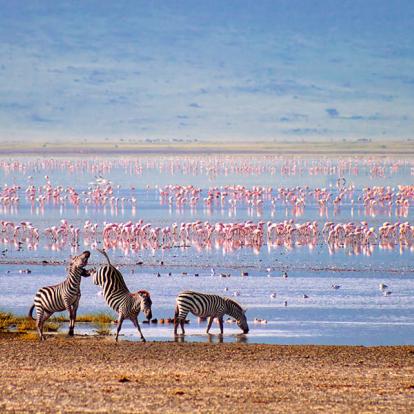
[{"x1": 93, "y1": 249, "x2": 152, "y2": 342}]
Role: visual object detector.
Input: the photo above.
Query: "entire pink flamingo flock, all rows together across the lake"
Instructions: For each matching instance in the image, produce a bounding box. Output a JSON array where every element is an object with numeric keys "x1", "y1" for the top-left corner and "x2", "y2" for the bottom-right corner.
[{"x1": 0, "y1": 157, "x2": 414, "y2": 254}]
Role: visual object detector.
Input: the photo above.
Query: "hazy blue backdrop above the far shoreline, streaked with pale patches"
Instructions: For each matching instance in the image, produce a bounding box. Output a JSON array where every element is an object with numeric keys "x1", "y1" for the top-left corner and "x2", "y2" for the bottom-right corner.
[{"x1": 0, "y1": 0, "x2": 414, "y2": 140}]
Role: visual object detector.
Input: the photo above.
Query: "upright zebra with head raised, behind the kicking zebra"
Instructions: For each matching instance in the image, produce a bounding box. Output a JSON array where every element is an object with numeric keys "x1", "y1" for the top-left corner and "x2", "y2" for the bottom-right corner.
[{"x1": 29, "y1": 251, "x2": 91, "y2": 341}]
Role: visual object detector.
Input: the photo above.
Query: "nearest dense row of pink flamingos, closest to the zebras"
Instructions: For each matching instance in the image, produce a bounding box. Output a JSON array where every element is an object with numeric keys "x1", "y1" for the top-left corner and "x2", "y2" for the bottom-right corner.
[{"x1": 0, "y1": 219, "x2": 414, "y2": 254}]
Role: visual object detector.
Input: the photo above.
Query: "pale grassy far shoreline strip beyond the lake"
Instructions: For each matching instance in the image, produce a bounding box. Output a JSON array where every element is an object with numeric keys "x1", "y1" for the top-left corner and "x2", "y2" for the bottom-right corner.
[{"x1": 0, "y1": 140, "x2": 414, "y2": 157}]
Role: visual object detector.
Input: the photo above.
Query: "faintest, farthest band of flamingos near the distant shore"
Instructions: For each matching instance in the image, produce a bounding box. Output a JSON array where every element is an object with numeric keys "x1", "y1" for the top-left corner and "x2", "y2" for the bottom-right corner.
[{"x1": 0, "y1": 155, "x2": 414, "y2": 177}]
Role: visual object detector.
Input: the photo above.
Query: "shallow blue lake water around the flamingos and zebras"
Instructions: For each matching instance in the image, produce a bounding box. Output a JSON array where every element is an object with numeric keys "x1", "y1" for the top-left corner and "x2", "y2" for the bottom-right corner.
[{"x1": 0, "y1": 155, "x2": 414, "y2": 345}]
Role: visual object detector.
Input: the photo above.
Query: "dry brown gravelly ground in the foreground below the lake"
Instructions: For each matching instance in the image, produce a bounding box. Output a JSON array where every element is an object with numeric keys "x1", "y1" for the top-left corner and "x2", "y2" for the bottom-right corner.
[{"x1": 0, "y1": 334, "x2": 414, "y2": 413}]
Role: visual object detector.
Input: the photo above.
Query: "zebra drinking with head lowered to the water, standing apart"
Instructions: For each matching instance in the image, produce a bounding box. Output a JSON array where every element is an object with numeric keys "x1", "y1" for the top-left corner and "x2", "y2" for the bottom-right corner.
[{"x1": 174, "y1": 291, "x2": 249, "y2": 335}]
